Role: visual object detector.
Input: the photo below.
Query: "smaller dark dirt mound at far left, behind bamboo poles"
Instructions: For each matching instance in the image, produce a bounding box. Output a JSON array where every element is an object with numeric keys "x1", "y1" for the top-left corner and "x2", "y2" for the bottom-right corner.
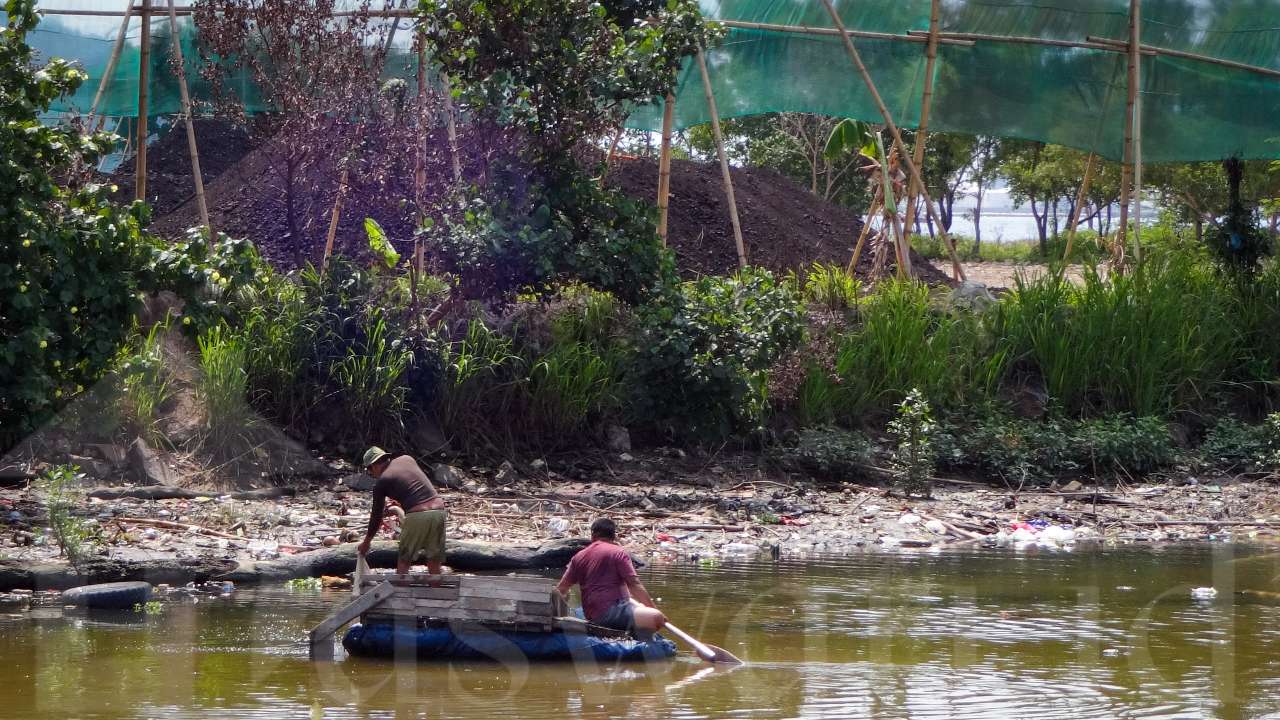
[{"x1": 111, "y1": 118, "x2": 256, "y2": 220}]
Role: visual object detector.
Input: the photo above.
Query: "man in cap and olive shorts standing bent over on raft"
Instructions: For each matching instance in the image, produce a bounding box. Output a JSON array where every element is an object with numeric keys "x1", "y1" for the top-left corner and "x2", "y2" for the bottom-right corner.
[{"x1": 356, "y1": 447, "x2": 444, "y2": 575}]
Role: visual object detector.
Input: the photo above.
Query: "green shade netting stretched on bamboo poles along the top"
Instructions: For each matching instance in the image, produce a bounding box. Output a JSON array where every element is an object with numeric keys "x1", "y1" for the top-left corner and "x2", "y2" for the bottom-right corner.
[{"x1": 15, "y1": 0, "x2": 1280, "y2": 163}]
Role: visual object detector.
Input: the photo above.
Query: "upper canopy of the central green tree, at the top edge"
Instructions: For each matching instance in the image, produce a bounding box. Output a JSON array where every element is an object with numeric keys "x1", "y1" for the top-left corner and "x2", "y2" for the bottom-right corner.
[{"x1": 420, "y1": 0, "x2": 718, "y2": 157}]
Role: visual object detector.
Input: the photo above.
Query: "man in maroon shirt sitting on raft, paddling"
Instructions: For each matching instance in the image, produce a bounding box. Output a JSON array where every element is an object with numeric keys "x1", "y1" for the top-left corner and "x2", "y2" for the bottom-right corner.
[{"x1": 556, "y1": 518, "x2": 667, "y2": 641}]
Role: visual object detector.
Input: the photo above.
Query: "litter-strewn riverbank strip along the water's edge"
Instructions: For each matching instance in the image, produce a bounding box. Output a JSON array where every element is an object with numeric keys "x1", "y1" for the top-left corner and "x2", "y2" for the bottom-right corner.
[{"x1": 0, "y1": 450, "x2": 1280, "y2": 589}]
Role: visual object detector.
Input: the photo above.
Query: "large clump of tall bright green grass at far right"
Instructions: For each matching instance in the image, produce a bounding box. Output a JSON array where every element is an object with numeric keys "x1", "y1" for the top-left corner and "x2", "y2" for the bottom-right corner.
[{"x1": 997, "y1": 255, "x2": 1238, "y2": 415}]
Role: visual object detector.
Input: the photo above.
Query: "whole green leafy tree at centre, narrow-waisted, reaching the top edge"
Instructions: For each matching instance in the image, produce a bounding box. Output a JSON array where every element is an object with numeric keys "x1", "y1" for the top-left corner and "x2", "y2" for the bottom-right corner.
[{"x1": 420, "y1": 0, "x2": 717, "y2": 301}]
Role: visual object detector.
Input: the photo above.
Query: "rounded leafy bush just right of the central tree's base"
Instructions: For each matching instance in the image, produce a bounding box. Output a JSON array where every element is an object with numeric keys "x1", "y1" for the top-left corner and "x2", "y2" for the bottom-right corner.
[{"x1": 631, "y1": 269, "x2": 804, "y2": 437}]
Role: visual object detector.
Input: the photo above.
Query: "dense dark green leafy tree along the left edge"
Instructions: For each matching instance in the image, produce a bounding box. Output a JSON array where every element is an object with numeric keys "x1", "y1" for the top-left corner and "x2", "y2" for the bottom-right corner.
[{"x1": 0, "y1": 0, "x2": 259, "y2": 451}]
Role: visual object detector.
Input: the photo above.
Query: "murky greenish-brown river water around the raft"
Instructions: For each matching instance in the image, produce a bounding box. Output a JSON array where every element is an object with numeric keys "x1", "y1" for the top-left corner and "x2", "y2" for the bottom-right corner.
[{"x1": 0, "y1": 544, "x2": 1280, "y2": 720}]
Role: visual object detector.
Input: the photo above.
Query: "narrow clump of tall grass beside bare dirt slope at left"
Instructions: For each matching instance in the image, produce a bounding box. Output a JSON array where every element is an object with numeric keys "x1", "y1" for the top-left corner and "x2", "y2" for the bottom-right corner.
[{"x1": 196, "y1": 324, "x2": 260, "y2": 455}]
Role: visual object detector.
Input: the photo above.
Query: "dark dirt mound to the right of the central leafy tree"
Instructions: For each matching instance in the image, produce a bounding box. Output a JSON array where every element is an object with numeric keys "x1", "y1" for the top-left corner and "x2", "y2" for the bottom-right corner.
[{"x1": 608, "y1": 159, "x2": 947, "y2": 283}]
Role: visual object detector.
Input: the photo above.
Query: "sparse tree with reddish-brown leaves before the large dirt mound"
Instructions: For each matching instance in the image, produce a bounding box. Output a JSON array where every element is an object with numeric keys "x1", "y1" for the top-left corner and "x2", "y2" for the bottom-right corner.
[{"x1": 195, "y1": 0, "x2": 403, "y2": 264}]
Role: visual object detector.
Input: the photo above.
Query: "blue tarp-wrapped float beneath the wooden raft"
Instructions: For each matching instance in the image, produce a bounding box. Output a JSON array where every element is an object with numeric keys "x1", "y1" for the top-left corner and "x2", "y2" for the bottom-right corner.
[{"x1": 342, "y1": 624, "x2": 676, "y2": 662}]
